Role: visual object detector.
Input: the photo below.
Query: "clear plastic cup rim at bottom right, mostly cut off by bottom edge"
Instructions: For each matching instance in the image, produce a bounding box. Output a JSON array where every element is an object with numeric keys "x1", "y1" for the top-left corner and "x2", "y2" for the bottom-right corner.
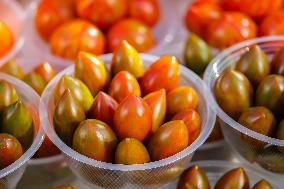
[{"x1": 163, "y1": 160, "x2": 283, "y2": 189}]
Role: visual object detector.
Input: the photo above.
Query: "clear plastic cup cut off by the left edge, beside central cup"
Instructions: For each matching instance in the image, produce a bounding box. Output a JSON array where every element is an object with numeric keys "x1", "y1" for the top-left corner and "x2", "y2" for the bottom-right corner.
[{"x1": 0, "y1": 73, "x2": 44, "y2": 189}]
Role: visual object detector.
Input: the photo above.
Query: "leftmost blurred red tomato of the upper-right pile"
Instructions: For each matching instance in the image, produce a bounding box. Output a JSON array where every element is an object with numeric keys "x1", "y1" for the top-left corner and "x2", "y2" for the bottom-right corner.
[{"x1": 185, "y1": 3, "x2": 222, "y2": 36}]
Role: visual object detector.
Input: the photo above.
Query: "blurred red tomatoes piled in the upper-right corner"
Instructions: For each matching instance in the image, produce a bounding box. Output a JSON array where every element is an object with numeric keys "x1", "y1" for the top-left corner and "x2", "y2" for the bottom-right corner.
[{"x1": 185, "y1": 0, "x2": 284, "y2": 49}]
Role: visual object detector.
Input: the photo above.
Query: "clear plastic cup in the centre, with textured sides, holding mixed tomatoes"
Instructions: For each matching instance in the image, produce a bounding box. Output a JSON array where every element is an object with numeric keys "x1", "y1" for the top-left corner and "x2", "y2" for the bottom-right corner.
[{"x1": 40, "y1": 54, "x2": 215, "y2": 188}]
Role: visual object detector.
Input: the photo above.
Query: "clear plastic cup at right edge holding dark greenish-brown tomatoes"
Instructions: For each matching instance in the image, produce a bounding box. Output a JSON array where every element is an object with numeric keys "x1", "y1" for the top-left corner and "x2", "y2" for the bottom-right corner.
[{"x1": 204, "y1": 36, "x2": 284, "y2": 178}]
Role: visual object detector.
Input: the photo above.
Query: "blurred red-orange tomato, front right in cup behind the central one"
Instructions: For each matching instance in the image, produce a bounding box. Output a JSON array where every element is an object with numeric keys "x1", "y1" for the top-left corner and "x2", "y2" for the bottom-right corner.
[{"x1": 107, "y1": 19, "x2": 155, "y2": 52}]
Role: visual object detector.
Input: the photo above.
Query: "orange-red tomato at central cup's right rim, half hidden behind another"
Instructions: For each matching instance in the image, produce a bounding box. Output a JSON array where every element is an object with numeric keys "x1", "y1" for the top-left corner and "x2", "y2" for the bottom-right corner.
[{"x1": 172, "y1": 109, "x2": 201, "y2": 144}]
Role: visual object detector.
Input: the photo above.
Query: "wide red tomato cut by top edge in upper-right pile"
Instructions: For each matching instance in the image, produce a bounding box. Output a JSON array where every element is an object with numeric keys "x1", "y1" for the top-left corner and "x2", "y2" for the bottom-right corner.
[{"x1": 220, "y1": 0, "x2": 282, "y2": 18}]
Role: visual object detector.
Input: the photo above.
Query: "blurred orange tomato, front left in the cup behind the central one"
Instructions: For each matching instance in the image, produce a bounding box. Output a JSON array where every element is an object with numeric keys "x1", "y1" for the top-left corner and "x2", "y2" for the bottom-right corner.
[{"x1": 49, "y1": 19, "x2": 105, "y2": 59}]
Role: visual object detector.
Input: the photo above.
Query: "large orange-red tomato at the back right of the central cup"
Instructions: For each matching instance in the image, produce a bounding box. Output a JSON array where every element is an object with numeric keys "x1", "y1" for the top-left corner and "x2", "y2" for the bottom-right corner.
[{"x1": 139, "y1": 56, "x2": 180, "y2": 95}]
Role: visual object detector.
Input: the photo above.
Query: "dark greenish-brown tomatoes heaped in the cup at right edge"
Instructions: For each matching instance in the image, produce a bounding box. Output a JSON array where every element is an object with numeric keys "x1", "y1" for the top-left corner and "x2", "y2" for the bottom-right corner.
[{"x1": 214, "y1": 45, "x2": 284, "y2": 152}]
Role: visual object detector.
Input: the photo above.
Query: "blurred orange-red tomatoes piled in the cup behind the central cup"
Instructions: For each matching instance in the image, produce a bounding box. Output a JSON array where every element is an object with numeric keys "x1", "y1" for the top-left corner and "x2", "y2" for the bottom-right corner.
[{"x1": 35, "y1": 0, "x2": 160, "y2": 59}]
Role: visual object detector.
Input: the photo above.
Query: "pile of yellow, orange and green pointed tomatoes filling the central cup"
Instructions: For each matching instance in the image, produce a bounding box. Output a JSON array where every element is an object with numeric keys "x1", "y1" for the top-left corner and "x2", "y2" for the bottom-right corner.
[{"x1": 53, "y1": 41, "x2": 202, "y2": 164}]
